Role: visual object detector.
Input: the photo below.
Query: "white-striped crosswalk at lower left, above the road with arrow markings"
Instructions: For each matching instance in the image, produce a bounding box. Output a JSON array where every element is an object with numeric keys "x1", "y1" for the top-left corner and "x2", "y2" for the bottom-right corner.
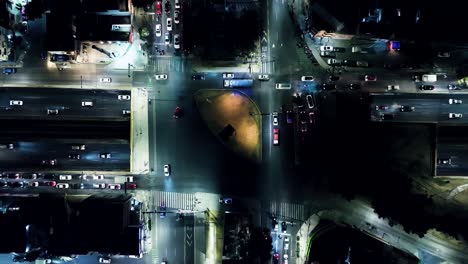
[{"x1": 152, "y1": 191, "x2": 196, "y2": 210}]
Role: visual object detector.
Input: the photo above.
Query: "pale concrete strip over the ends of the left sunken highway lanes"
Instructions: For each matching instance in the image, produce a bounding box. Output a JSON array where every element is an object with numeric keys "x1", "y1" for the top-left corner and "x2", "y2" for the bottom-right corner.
[{"x1": 130, "y1": 88, "x2": 149, "y2": 174}]
